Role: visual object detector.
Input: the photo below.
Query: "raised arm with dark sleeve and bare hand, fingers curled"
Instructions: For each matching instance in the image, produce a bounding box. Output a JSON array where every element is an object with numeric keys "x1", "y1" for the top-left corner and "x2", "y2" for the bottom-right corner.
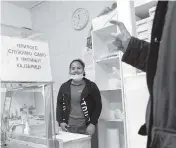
[{"x1": 110, "y1": 20, "x2": 150, "y2": 71}]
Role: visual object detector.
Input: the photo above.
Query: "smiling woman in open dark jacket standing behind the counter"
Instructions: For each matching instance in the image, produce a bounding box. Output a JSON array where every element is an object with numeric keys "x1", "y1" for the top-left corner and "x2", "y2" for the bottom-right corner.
[{"x1": 56, "y1": 59, "x2": 102, "y2": 135}]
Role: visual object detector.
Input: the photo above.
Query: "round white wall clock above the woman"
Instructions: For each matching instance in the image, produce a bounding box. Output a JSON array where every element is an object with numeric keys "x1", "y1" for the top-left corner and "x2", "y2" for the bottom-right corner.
[{"x1": 72, "y1": 8, "x2": 89, "y2": 30}]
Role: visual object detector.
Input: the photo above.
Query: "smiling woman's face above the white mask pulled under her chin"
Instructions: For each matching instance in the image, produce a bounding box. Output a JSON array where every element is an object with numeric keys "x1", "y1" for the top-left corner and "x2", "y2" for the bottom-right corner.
[{"x1": 70, "y1": 61, "x2": 84, "y2": 75}]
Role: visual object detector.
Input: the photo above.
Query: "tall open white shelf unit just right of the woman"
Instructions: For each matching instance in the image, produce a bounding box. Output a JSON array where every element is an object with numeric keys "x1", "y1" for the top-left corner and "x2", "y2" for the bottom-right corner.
[{"x1": 92, "y1": 20, "x2": 125, "y2": 148}]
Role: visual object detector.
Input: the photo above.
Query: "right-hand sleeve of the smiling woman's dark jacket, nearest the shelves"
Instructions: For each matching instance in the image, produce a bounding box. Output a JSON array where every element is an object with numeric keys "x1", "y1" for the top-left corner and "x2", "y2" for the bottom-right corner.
[{"x1": 90, "y1": 83, "x2": 102, "y2": 125}]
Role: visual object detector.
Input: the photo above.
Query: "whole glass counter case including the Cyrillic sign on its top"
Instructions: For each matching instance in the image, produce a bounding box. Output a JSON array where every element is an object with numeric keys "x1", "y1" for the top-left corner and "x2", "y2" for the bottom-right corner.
[{"x1": 0, "y1": 24, "x2": 61, "y2": 148}]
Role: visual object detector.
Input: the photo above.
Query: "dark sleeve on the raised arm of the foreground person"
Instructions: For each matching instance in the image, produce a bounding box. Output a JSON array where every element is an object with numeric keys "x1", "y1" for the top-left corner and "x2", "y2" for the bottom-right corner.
[{"x1": 122, "y1": 37, "x2": 150, "y2": 72}]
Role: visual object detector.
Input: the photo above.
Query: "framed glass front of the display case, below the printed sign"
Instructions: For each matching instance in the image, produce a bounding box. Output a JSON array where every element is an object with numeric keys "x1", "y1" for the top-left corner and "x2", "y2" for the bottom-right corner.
[{"x1": 1, "y1": 82, "x2": 59, "y2": 148}]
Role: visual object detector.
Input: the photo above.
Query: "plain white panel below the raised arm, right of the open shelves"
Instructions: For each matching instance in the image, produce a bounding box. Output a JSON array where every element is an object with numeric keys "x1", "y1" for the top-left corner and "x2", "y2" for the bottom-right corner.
[{"x1": 124, "y1": 75, "x2": 149, "y2": 148}]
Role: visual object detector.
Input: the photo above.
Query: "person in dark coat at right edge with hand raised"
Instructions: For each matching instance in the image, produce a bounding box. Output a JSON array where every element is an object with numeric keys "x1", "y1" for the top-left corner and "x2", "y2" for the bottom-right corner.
[{"x1": 111, "y1": 1, "x2": 176, "y2": 148}]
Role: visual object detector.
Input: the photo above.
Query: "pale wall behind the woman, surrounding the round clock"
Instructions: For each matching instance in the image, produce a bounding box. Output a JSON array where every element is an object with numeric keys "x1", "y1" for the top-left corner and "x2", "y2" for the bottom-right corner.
[{"x1": 32, "y1": 1, "x2": 112, "y2": 105}]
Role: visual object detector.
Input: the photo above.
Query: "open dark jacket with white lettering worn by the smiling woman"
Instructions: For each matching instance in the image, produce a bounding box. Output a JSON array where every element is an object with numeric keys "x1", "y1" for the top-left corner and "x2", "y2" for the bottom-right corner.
[{"x1": 56, "y1": 78, "x2": 102, "y2": 125}]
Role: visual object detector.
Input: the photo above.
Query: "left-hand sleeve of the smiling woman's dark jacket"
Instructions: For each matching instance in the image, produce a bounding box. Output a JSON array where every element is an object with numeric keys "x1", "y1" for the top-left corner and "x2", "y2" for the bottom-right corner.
[{"x1": 56, "y1": 86, "x2": 63, "y2": 125}]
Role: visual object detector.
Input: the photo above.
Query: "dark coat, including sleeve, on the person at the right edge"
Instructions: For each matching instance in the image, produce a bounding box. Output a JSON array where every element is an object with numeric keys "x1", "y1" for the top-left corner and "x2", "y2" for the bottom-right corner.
[{"x1": 122, "y1": 1, "x2": 176, "y2": 148}]
